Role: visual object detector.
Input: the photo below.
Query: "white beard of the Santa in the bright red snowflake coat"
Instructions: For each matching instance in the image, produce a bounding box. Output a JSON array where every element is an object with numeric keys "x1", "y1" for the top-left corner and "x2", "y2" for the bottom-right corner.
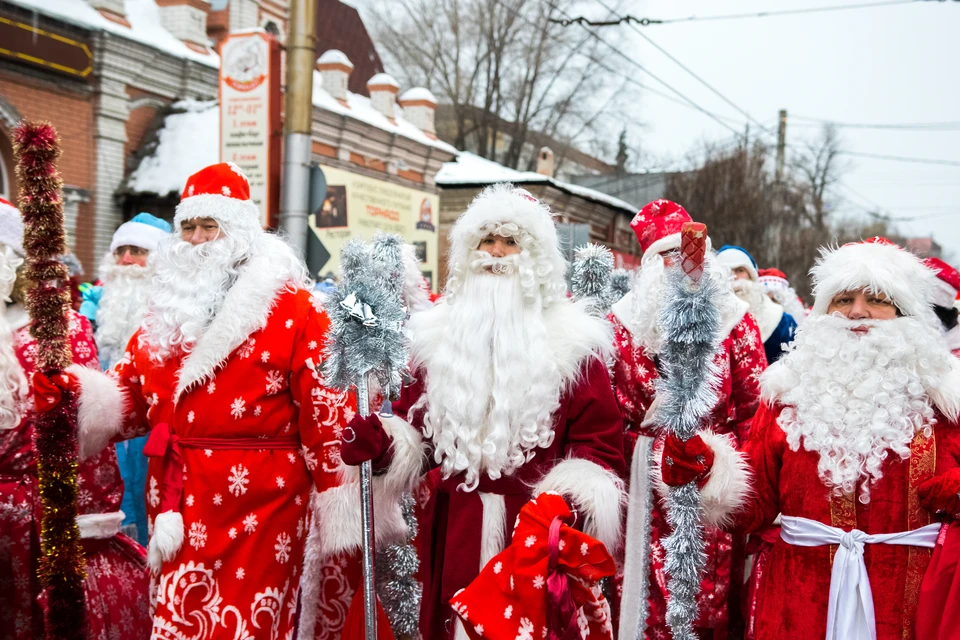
[{"x1": 140, "y1": 234, "x2": 253, "y2": 362}]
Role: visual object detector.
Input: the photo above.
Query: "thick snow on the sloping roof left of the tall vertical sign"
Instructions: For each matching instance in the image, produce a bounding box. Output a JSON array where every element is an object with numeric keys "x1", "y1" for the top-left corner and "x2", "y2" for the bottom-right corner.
[{"x1": 126, "y1": 100, "x2": 220, "y2": 196}]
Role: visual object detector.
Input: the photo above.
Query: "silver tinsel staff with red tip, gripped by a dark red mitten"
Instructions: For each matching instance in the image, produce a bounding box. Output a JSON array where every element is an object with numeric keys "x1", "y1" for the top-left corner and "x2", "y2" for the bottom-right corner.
[{"x1": 656, "y1": 222, "x2": 720, "y2": 640}]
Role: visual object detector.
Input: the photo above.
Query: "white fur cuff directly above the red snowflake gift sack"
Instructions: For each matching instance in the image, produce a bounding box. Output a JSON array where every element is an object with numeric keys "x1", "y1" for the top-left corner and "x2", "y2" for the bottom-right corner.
[{"x1": 533, "y1": 458, "x2": 627, "y2": 555}]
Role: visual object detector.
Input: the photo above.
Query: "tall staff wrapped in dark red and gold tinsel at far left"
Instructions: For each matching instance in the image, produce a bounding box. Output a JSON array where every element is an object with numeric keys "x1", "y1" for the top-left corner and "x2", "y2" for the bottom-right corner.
[{"x1": 14, "y1": 122, "x2": 86, "y2": 640}]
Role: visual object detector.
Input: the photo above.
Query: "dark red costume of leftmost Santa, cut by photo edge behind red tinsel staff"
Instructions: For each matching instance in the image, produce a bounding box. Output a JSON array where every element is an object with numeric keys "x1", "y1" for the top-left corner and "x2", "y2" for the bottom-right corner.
[{"x1": 0, "y1": 202, "x2": 150, "y2": 640}]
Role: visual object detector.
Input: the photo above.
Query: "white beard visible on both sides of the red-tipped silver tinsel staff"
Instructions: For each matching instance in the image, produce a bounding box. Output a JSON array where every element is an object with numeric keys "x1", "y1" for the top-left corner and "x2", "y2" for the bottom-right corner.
[{"x1": 631, "y1": 254, "x2": 743, "y2": 356}]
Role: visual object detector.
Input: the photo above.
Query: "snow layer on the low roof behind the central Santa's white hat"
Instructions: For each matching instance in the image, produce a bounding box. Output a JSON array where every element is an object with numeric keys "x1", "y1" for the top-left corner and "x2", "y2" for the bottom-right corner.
[{"x1": 434, "y1": 151, "x2": 639, "y2": 215}]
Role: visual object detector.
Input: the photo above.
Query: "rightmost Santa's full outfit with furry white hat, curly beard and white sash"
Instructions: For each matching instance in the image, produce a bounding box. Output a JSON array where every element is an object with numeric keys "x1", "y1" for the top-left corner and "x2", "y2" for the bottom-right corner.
[{"x1": 664, "y1": 239, "x2": 960, "y2": 640}]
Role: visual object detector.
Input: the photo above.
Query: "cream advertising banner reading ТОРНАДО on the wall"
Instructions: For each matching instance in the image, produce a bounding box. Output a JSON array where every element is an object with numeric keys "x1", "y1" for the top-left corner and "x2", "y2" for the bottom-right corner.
[{"x1": 310, "y1": 167, "x2": 440, "y2": 291}]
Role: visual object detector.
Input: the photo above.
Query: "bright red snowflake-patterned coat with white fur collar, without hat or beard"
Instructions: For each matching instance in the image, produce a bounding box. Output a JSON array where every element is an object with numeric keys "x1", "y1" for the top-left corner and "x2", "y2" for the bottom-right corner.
[{"x1": 74, "y1": 256, "x2": 356, "y2": 638}]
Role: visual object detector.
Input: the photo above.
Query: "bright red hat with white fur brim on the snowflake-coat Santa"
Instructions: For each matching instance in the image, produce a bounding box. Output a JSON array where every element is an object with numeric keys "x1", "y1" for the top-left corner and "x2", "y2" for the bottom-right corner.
[{"x1": 173, "y1": 162, "x2": 260, "y2": 228}]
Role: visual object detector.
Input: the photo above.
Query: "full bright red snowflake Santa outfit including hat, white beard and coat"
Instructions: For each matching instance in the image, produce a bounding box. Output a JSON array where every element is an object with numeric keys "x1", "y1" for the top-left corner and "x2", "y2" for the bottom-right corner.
[{"x1": 73, "y1": 163, "x2": 353, "y2": 638}]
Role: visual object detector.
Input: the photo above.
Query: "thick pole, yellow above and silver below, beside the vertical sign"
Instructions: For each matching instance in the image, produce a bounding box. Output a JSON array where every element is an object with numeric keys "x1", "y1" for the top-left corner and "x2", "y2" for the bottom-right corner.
[{"x1": 280, "y1": 0, "x2": 317, "y2": 257}]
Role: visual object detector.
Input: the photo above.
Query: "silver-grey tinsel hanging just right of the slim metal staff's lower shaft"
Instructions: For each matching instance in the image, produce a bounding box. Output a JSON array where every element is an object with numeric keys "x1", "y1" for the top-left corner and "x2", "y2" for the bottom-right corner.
[{"x1": 377, "y1": 493, "x2": 423, "y2": 639}]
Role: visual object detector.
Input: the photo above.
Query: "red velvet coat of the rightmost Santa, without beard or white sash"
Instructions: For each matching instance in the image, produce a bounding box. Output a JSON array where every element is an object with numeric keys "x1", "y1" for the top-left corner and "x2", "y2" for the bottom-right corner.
[{"x1": 735, "y1": 400, "x2": 960, "y2": 640}]
